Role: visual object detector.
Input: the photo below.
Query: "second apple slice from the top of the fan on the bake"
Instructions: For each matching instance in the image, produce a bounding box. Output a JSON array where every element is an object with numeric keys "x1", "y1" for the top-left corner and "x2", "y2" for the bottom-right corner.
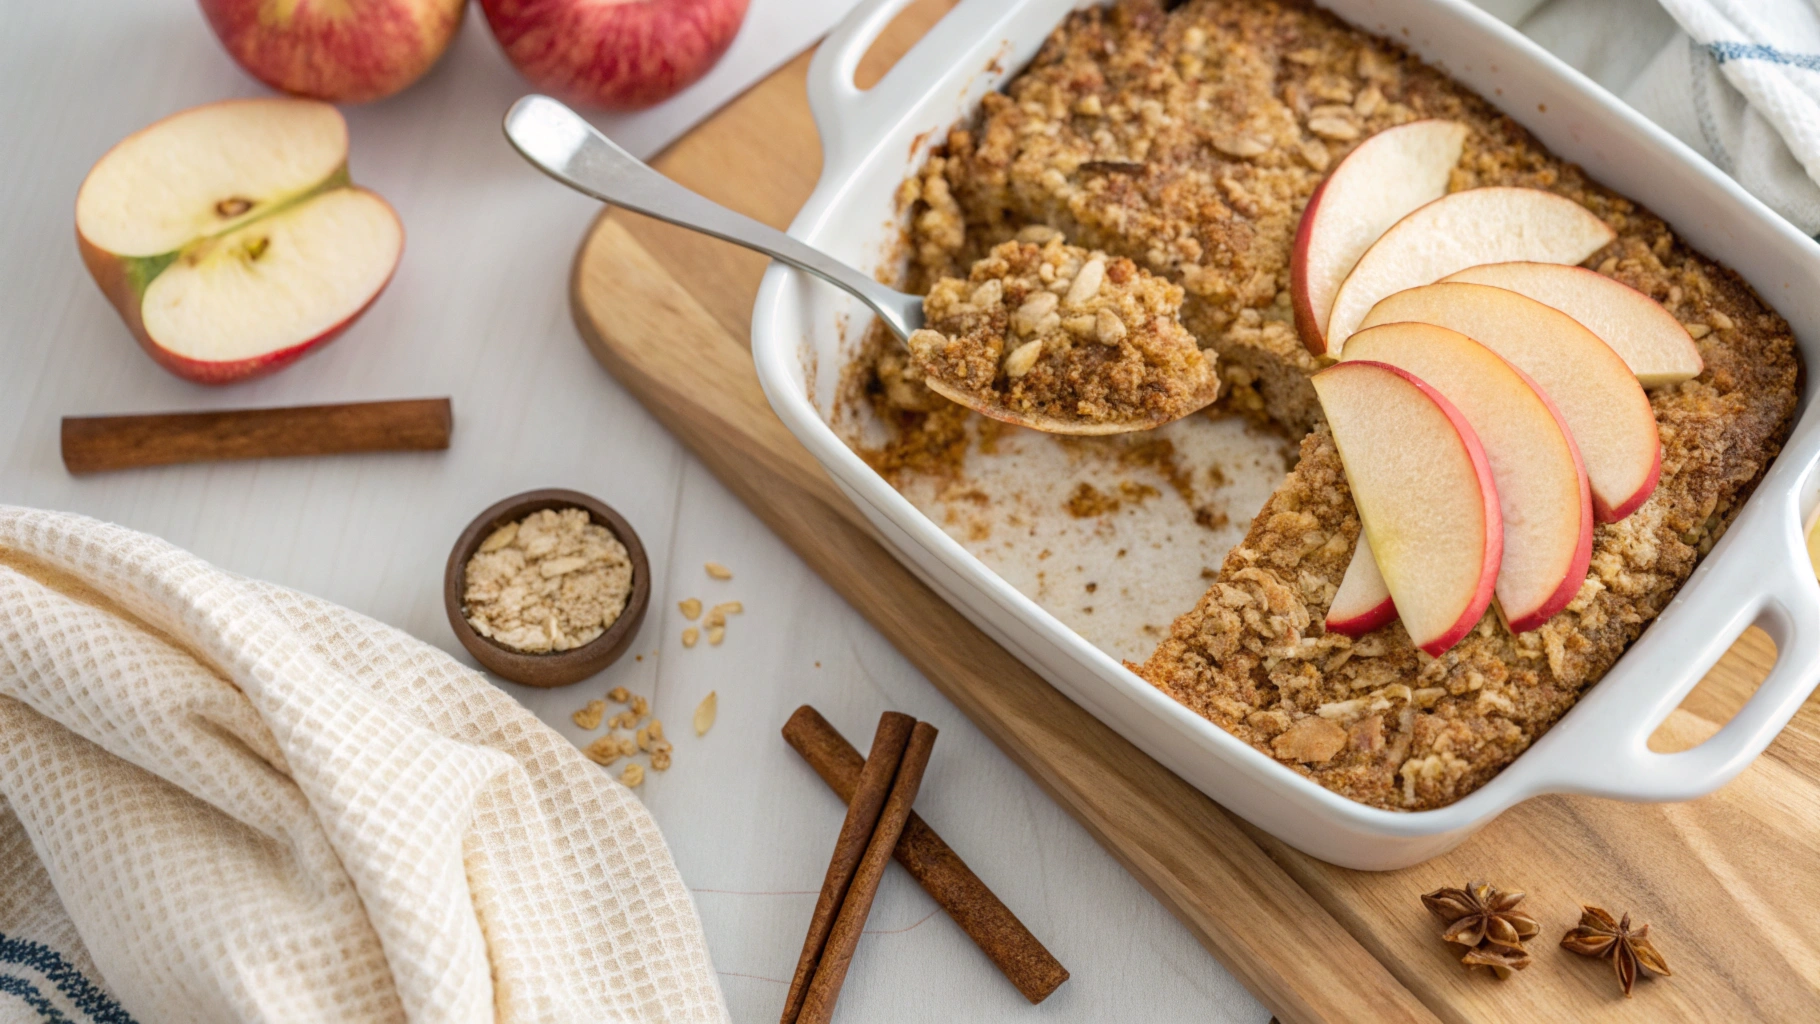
[{"x1": 1316, "y1": 187, "x2": 1616, "y2": 356}]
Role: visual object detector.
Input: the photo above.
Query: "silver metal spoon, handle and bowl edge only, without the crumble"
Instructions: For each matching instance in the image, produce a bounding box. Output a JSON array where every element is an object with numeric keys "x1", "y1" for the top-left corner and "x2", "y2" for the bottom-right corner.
[{"x1": 506, "y1": 95, "x2": 1210, "y2": 435}]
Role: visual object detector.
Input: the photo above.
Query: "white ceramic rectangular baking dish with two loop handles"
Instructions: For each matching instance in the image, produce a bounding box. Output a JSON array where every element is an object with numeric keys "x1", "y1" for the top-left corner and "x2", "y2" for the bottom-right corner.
[{"x1": 752, "y1": 0, "x2": 1820, "y2": 869}]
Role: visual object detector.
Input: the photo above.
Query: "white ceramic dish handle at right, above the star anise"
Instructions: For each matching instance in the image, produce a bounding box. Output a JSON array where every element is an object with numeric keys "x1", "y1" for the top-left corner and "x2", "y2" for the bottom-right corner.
[{"x1": 1534, "y1": 460, "x2": 1820, "y2": 800}]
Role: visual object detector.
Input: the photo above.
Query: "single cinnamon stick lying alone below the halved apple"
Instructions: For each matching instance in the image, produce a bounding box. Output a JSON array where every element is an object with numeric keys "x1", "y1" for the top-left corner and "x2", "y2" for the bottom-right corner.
[{"x1": 64, "y1": 398, "x2": 455, "y2": 475}]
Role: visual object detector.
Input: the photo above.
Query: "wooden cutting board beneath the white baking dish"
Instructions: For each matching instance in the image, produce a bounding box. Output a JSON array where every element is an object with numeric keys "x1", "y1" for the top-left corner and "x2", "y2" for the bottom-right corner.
[{"x1": 571, "y1": 0, "x2": 1820, "y2": 1024}]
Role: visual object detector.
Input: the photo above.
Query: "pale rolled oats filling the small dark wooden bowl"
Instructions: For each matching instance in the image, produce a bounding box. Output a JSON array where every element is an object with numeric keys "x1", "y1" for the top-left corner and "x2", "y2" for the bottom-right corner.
[{"x1": 462, "y1": 509, "x2": 632, "y2": 653}]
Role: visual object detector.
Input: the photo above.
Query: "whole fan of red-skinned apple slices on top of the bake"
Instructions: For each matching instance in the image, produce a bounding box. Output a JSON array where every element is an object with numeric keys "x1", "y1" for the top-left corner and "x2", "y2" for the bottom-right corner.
[{"x1": 1290, "y1": 120, "x2": 1704, "y2": 657}]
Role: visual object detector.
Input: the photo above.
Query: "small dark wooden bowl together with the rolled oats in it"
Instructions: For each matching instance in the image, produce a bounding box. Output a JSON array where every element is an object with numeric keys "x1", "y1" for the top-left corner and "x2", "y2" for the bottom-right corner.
[{"x1": 442, "y1": 489, "x2": 652, "y2": 686}]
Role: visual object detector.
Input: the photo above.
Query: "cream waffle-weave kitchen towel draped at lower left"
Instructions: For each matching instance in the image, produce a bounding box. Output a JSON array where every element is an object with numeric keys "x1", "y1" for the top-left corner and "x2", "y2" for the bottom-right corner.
[{"x1": 0, "y1": 506, "x2": 726, "y2": 1024}]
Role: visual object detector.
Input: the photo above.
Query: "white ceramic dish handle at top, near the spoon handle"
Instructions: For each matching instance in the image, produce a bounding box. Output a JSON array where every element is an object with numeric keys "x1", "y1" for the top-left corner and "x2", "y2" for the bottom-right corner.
[{"x1": 808, "y1": 0, "x2": 946, "y2": 176}]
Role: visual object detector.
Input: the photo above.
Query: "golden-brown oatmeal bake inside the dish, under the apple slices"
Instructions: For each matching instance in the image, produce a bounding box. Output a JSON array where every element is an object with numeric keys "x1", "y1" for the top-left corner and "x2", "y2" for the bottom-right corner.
[{"x1": 855, "y1": 0, "x2": 1800, "y2": 811}]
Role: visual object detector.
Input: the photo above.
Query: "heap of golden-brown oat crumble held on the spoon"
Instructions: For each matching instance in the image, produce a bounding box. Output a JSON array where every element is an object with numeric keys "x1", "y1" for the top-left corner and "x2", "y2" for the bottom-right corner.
[{"x1": 908, "y1": 234, "x2": 1219, "y2": 433}]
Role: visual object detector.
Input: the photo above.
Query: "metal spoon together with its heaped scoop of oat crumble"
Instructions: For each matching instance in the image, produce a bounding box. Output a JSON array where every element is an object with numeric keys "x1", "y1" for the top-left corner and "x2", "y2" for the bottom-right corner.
[{"x1": 506, "y1": 96, "x2": 1219, "y2": 435}]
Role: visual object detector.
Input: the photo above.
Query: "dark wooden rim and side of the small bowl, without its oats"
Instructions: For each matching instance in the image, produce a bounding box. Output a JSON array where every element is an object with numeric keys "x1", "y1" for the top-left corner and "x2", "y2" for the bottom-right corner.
[{"x1": 442, "y1": 489, "x2": 652, "y2": 688}]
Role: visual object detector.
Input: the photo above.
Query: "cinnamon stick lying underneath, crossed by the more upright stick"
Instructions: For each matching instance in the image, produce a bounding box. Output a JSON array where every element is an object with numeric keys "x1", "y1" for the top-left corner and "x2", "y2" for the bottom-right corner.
[{"x1": 784, "y1": 704, "x2": 1068, "y2": 1002}]
